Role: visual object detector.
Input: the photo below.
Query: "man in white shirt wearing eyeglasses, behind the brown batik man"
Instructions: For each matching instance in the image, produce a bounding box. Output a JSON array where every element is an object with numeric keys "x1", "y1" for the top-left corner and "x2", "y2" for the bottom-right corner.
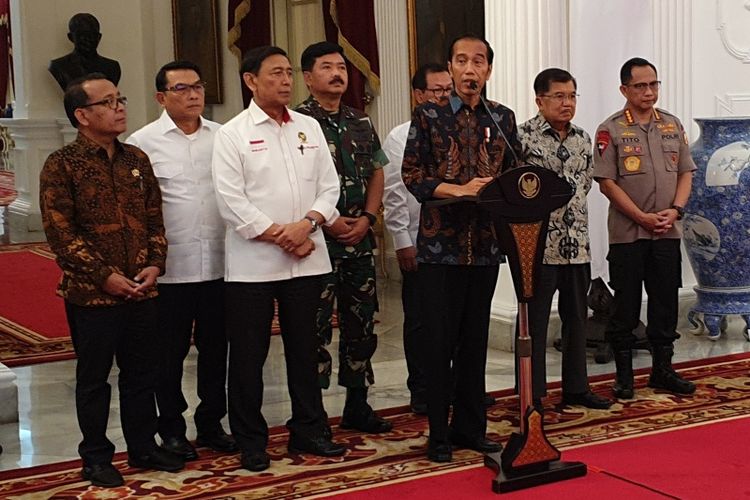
[{"x1": 127, "y1": 61, "x2": 236, "y2": 460}]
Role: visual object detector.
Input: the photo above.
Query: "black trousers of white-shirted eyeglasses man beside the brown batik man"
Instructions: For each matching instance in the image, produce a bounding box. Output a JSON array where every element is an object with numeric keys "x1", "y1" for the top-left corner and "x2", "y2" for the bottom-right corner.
[{"x1": 156, "y1": 279, "x2": 227, "y2": 439}]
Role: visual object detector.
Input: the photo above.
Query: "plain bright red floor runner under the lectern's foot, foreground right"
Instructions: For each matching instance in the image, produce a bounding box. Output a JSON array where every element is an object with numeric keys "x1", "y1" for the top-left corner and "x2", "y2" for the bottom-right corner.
[{"x1": 335, "y1": 418, "x2": 750, "y2": 500}]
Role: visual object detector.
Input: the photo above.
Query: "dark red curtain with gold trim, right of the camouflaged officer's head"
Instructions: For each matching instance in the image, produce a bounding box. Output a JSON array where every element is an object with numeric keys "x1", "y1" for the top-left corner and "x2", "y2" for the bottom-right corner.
[{"x1": 323, "y1": 0, "x2": 380, "y2": 111}]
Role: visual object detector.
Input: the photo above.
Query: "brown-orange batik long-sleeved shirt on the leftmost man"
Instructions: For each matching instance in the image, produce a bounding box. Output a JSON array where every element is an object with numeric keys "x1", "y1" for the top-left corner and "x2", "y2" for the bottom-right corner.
[{"x1": 39, "y1": 134, "x2": 167, "y2": 306}]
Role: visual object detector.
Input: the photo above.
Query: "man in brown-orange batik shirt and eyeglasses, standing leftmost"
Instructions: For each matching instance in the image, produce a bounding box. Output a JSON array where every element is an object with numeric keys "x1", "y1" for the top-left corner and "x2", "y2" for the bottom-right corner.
[{"x1": 39, "y1": 73, "x2": 184, "y2": 487}]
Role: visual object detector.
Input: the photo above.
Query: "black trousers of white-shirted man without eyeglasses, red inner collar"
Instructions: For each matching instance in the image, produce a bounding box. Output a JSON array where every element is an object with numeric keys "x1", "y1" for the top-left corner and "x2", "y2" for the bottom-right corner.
[{"x1": 226, "y1": 276, "x2": 328, "y2": 452}]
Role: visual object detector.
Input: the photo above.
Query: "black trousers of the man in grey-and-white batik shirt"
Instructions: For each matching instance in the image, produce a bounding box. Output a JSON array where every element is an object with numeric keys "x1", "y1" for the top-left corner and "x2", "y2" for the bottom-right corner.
[{"x1": 516, "y1": 264, "x2": 591, "y2": 398}]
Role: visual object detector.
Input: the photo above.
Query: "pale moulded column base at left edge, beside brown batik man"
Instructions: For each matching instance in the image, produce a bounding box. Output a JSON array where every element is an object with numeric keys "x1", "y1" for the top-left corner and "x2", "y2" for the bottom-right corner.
[{"x1": 0, "y1": 118, "x2": 63, "y2": 231}]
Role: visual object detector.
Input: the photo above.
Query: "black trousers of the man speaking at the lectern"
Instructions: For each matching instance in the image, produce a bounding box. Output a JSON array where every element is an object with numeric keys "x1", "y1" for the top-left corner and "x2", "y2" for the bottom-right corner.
[{"x1": 417, "y1": 263, "x2": 499, "y2": 444}]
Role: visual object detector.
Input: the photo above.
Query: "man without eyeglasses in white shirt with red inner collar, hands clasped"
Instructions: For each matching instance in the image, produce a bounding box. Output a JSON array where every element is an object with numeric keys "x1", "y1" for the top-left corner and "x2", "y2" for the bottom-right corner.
[{"x1": 213, "y1": 46, "x2": 346, "y2": 471}]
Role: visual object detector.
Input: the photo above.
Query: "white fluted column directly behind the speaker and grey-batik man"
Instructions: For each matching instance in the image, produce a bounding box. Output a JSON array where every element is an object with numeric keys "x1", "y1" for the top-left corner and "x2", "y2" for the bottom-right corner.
[{"x1": 484, "y1": 0, "x2": 569, "y2": 351}]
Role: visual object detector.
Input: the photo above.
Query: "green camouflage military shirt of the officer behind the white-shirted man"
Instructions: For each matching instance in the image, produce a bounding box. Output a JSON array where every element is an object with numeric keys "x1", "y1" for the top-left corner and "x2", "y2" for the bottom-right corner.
[{"x1": 295, "y1": 96, "x2": 388, "y2": 258}]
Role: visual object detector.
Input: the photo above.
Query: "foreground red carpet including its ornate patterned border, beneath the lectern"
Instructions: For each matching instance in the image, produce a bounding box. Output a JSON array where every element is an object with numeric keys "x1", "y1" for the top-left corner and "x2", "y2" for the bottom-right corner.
[{"x1": 0, "y1": 354, "x2": 750, "y2": 500}]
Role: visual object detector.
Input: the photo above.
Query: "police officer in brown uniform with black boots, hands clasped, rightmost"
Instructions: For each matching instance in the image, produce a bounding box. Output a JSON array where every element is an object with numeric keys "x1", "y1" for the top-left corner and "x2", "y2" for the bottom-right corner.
[{"x1": 594, "y1": 58, "x2": 696, "y2": 399}]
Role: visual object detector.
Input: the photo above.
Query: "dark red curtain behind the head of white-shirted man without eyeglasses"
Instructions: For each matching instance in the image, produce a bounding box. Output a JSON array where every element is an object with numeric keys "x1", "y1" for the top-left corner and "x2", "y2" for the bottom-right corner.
[{"x1": 231, "y1": 0, "x2": 271, "y2": 107}]
